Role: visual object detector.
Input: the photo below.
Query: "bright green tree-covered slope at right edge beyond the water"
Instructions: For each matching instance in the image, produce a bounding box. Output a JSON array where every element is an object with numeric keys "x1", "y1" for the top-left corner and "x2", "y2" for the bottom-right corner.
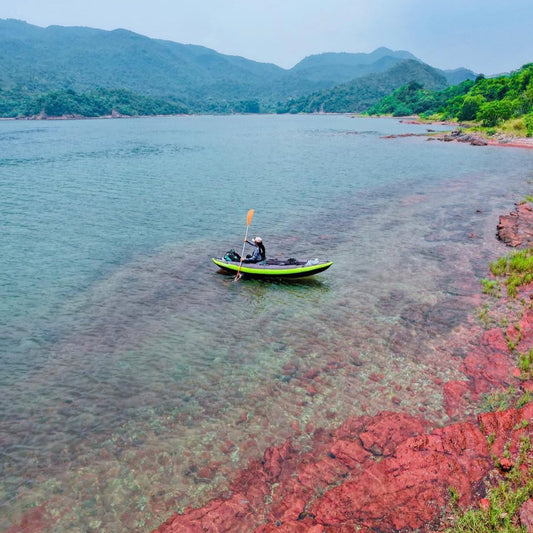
[{"x1": 368, "y1": 63, "x2": 533, "y2": 137}]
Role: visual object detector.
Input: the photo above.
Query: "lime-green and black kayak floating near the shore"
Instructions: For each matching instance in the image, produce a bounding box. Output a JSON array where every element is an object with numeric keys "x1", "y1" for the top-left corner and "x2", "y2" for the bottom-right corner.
[{"x1": 212, "y1": 257, "x2": 333, "y2": 279}]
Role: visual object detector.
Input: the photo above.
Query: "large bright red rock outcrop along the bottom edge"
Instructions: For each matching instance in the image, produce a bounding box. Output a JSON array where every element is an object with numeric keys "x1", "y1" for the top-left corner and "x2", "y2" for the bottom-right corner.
[{"x1": 154, "y1": 404, "x2": 533, "y2": 533}]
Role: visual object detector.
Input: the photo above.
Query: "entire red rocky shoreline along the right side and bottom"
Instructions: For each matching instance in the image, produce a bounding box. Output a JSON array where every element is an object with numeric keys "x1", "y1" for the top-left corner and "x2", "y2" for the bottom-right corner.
[{"x1": 153, "y1": 204, "x2": 533, "y2": 533}]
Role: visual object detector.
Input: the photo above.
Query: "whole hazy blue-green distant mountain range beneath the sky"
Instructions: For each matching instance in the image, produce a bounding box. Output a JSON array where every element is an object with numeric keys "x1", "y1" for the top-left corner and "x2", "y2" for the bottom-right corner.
[{"x1": 0, "y1": 19, "x2": 476, "y2": 112}]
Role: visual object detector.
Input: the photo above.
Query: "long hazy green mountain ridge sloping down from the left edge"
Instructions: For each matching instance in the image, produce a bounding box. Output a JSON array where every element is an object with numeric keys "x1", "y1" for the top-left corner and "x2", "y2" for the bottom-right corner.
[{"x1": 0, "y1": 20, "x2": 283, "y2": 99}]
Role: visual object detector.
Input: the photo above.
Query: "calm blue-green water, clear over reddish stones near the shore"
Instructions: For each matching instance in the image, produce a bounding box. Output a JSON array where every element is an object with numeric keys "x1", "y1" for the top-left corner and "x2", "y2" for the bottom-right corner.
[{"x1": 0, "y1": 116, "x2": 533, "y2": 532}]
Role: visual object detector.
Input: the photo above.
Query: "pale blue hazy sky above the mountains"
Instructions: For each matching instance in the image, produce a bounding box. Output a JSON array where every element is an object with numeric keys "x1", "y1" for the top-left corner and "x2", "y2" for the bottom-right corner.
[{"x1": 0, "y1": 0, "x2": 533, "y2": 75}]
